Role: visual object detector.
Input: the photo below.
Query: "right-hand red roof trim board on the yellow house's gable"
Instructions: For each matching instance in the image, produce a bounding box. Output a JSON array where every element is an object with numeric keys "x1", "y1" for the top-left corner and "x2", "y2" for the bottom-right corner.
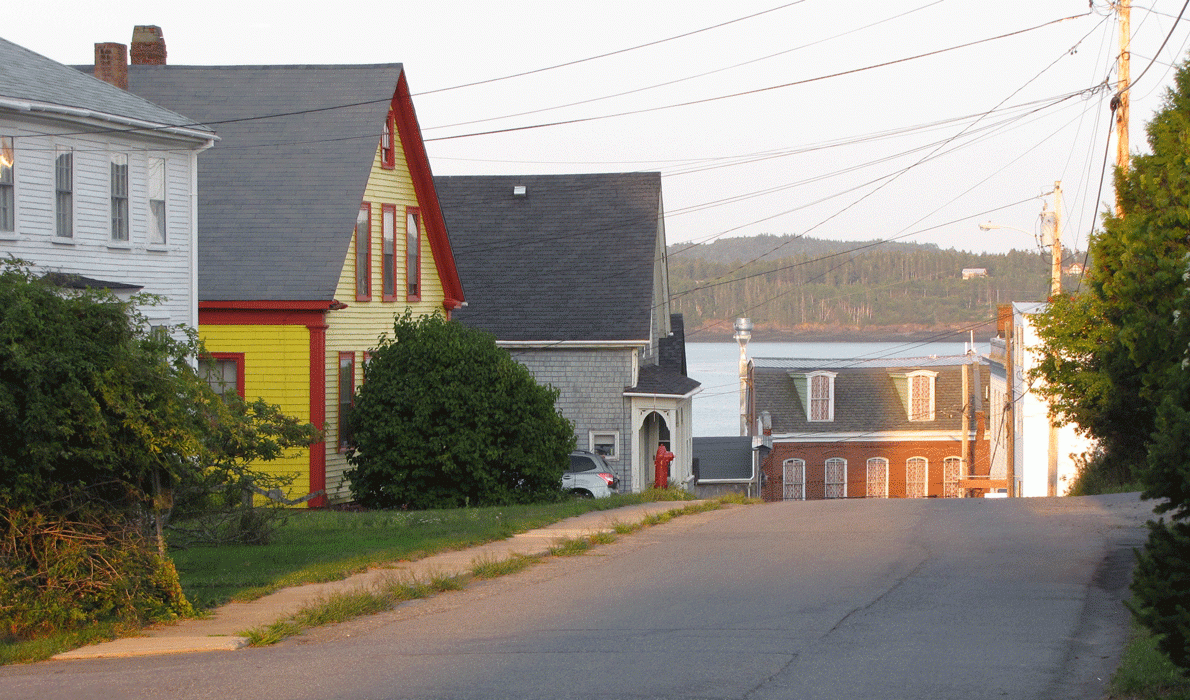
[{"x1": 393, "y1": 70, "x2": 464, "y2": 310}]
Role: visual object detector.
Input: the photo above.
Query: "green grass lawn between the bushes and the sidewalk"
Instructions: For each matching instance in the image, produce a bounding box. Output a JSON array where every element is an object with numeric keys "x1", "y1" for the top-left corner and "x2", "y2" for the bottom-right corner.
[{"x1": 170, "y1": 492, "x2": 689, "y2": 608}]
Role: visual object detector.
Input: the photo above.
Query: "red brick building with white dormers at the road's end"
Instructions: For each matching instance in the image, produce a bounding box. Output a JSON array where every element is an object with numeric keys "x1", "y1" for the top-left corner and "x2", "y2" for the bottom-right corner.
[{"x1": 750, "y1": 355, "x2": 990, "y2": 501}]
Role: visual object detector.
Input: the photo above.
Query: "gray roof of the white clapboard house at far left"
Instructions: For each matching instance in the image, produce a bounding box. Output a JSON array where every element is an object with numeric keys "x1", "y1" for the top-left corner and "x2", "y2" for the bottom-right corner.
[{"x1": 0, "y1": 39, "x2": 209, "y2": 132}]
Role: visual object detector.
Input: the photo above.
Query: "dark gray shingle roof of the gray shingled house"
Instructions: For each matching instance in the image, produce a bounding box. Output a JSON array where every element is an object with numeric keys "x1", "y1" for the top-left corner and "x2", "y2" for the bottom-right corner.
[{"x1": 434, "y1": 173, "x2": 662, "y2": 340}]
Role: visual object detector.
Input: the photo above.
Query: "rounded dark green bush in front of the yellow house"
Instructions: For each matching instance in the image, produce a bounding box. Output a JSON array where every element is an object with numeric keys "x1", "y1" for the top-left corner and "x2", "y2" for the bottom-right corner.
[{"x1": 346, "y1": 311, "x2": 575, "y2": 508}]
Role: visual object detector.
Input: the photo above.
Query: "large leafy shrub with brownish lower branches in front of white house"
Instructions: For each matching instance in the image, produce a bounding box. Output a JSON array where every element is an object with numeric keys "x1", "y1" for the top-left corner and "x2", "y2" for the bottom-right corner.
[{"x1": 0, "y1": 260, "x2": 317, "y2": 636}]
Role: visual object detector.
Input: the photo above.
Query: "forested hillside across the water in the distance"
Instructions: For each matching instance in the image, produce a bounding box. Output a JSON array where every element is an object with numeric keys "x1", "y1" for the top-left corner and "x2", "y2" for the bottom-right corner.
[{"x1": 669, "y1": 236, "x2": 1082, "y2": 330}]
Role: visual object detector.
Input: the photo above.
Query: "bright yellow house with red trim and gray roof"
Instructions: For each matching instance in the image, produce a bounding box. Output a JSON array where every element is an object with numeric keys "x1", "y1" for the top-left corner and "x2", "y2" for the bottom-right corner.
[{"x1": 129, "y1": 54, "x2": 464, "y2": 506}]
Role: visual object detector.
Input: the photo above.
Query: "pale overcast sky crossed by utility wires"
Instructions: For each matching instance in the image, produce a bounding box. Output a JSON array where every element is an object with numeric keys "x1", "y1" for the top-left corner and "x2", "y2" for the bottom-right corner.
[{"x1": 9, "y1": 0, "x2": 1190, "y2": 252}]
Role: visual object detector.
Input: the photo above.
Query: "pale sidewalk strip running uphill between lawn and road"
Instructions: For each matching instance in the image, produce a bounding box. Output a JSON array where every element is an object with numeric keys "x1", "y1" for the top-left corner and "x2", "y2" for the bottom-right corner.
[{"x1": 54, "y1": 501, "x2": 702, "y2": 661}]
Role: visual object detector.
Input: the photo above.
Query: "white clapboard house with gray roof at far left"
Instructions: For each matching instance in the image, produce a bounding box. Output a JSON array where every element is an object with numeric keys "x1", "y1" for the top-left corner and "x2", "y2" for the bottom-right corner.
[{"x1": 0, "y1": 39, "x2": 215, "y2": 335}]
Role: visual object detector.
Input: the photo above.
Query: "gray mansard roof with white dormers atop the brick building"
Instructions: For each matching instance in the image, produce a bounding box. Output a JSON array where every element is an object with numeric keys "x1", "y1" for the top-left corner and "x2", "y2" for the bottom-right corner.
[{"x1": 753, "y1": 355, "x2": 988, "y2": 435}]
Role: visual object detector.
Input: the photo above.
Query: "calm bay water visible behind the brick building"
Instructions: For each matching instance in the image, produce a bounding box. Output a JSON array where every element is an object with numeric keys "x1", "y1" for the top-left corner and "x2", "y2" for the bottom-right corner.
[{"x1": 685, "y1": 340, "x2": 988, "y2": 437}]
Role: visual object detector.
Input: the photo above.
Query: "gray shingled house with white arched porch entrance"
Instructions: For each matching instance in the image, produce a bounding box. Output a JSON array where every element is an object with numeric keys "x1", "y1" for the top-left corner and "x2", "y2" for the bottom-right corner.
[{"x1": 434, "y1": 173, "x2": 699, "y2": 490}]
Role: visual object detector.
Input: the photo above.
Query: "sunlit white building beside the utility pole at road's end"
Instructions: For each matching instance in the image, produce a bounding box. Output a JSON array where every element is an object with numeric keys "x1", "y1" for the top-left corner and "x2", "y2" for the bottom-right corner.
[{"x1": 988, "y1": 302, "x2": 1095, "y2": 496}]
